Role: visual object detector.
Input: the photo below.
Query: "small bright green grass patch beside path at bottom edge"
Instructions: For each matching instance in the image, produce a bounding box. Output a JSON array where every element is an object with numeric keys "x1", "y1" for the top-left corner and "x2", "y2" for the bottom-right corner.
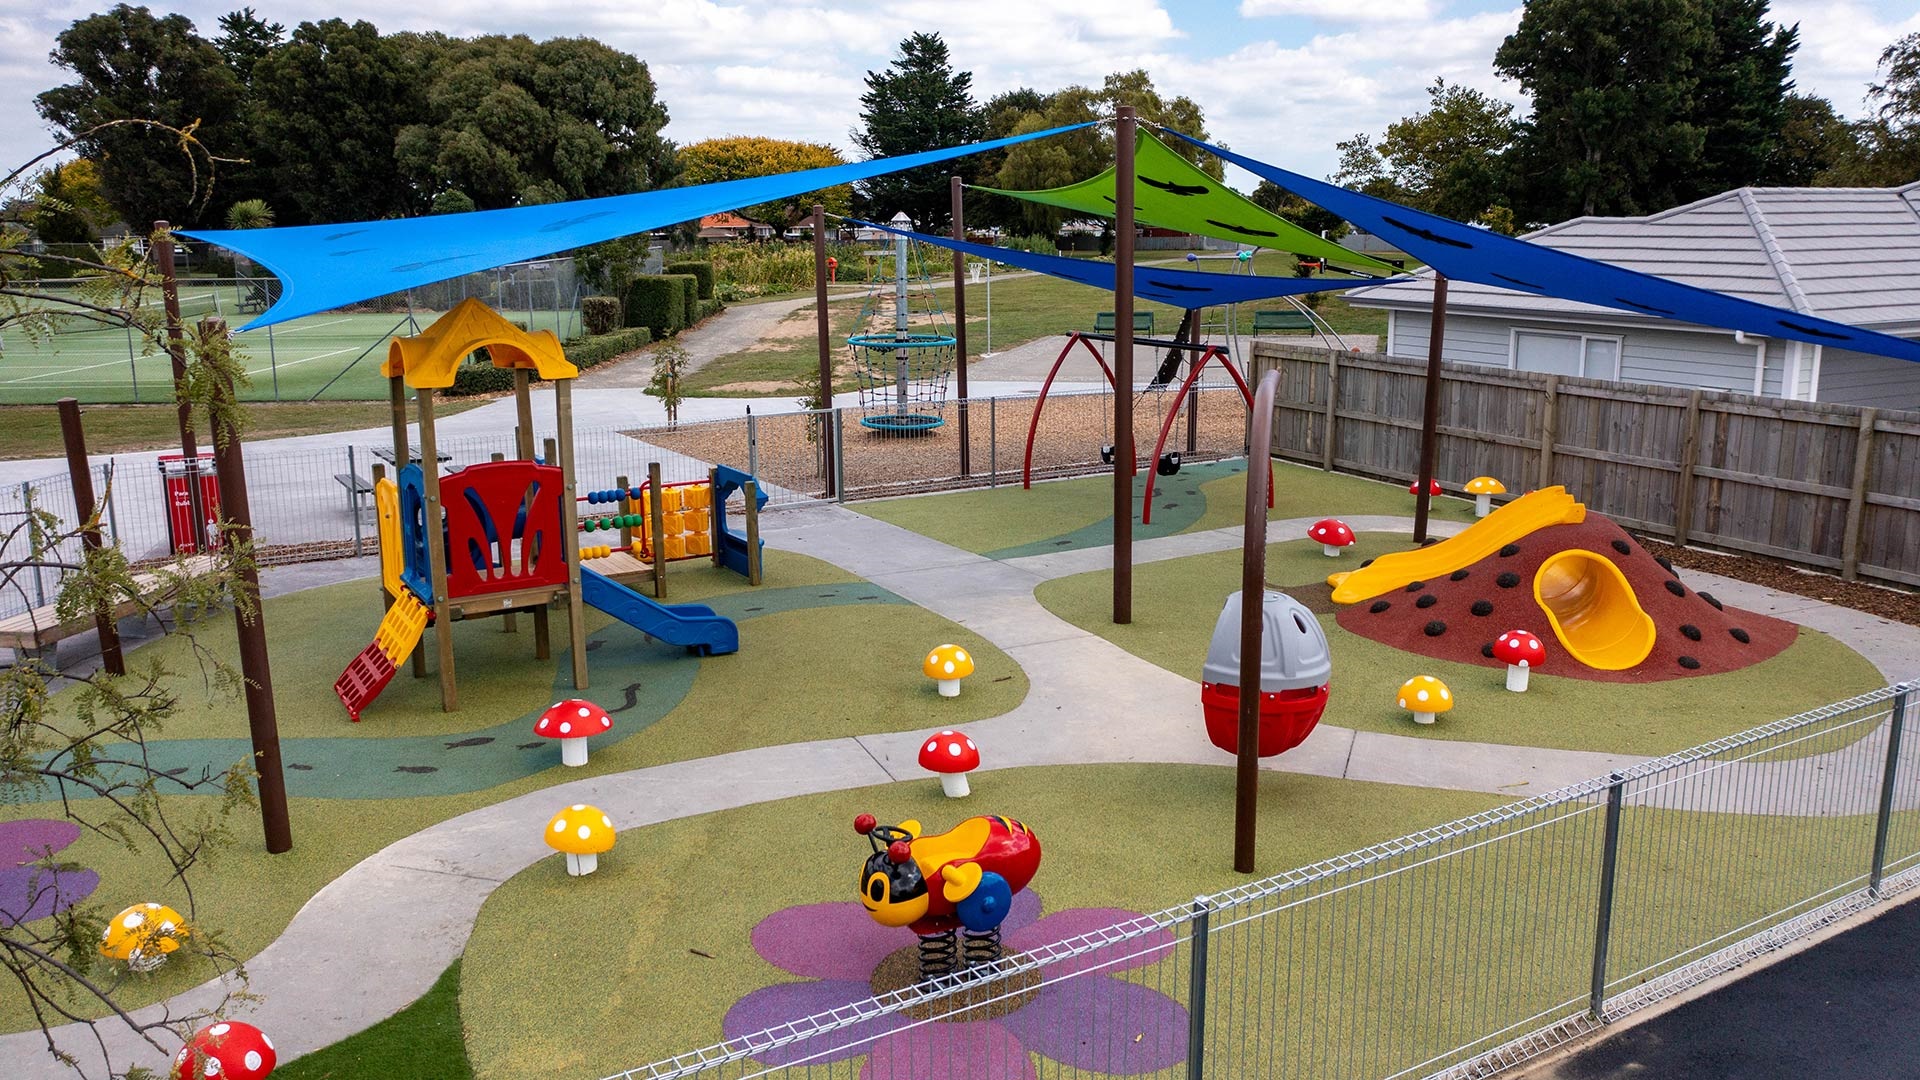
[{"x1": 273, "y1": 961, "x2": 474, "y2": 1080}]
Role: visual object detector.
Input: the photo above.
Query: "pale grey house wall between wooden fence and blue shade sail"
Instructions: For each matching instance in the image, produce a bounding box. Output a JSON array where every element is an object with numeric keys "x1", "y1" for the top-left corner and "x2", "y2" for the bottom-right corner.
[{"x1": 1388, "y1": 311, "x2": 1781, "y2": 394}]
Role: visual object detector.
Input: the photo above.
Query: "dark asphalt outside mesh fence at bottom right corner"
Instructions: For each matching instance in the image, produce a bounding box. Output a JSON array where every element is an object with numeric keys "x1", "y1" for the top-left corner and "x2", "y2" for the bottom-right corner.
[{"x1": 1540, "y1": 891, "x2": 1920, "y2": 1080}]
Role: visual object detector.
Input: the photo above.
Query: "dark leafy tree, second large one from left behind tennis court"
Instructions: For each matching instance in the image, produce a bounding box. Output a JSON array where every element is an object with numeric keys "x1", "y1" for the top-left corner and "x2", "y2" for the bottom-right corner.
[{"x1": 248, "y1": 19, "x2": 432, "y2": 225}]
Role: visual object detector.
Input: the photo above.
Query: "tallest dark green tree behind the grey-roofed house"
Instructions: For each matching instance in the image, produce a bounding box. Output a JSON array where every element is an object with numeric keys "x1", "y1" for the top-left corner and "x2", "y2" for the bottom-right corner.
[{"x1": 1494, "y1": 0, "x2": 1711, "y2": 221}]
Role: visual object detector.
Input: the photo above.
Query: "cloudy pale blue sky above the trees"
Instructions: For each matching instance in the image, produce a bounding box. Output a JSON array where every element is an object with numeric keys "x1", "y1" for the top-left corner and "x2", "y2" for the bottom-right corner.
[{"x1": 0, "y1": 0, "x2": 1920, "y2": 196}]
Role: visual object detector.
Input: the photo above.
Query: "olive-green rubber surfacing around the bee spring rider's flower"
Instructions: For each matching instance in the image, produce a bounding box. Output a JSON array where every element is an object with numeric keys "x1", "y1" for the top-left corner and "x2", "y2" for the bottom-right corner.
[{"x1": 461, "y1": 765, "x2": 1501, "y2": 1080}]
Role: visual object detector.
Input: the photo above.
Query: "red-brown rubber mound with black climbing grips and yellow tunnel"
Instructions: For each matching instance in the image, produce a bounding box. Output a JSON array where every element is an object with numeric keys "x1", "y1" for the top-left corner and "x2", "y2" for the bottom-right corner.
[{"x1": 1338, "y1": 515, "x2": 1799, "y2": 682}]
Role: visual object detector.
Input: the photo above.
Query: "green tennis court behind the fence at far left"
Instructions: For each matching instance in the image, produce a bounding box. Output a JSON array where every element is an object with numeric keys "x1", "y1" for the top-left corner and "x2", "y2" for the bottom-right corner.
[{"x1": 0, "y1": 269, "x2": 580, "y2": 405}]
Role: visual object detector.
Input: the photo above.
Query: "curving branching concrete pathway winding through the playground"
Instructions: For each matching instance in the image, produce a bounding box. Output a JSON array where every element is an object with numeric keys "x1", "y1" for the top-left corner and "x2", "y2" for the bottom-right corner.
[{"x1": 0, "y1": 505, "x2": 1920, "y2": 1080}]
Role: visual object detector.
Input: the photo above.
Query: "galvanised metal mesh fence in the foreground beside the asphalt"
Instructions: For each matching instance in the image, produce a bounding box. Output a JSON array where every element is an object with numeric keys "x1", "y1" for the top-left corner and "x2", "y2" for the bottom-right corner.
[{"x1": 616, "y1": 684, "x2": 1920, "y2": 1080}]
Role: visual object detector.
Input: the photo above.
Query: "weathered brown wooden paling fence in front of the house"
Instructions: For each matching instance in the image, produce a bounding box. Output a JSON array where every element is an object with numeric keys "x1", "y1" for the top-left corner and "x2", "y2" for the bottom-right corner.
[{"x1": 1254, "y1": 340, "x2": 1920, "y2": 584}]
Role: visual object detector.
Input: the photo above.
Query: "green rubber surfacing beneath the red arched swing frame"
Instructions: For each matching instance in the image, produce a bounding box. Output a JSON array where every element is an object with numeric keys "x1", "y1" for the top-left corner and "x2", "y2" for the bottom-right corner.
[{"x1": 852, "y1": 453, "x2": 1473, "y2": 557}]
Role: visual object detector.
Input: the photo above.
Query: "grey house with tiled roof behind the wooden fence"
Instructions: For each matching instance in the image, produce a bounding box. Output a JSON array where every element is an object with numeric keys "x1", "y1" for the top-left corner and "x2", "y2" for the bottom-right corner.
[{"x1": 1348, "y1": 183, "x2": 1920, "y2": 409}]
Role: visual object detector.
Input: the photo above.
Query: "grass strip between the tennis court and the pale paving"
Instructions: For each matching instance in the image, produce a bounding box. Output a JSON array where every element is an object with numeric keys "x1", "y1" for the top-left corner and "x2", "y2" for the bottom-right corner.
[{"x1": 0, "y1": 398, "x2": 486, "y2": 461}]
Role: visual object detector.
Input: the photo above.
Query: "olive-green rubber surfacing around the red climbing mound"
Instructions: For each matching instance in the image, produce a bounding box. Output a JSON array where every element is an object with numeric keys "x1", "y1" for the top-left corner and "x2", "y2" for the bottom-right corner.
[{"x1": 1035, "y1": 532, "x2": 1885, "y2": 755}]
